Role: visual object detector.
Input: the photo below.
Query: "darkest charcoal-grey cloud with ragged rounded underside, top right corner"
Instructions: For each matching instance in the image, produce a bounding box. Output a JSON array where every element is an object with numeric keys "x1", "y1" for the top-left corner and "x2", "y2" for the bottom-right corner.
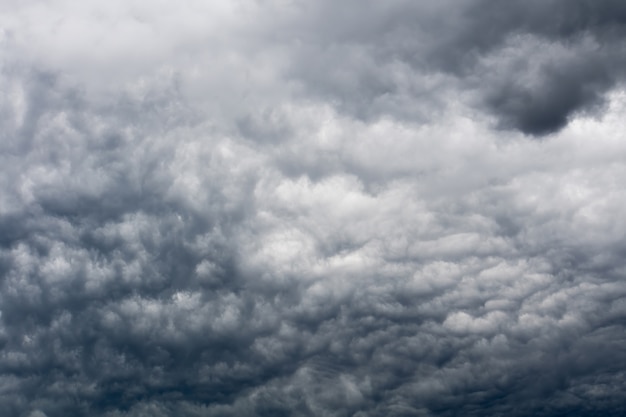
[{"x1": 459, "y1": 1, "x2": 626, "y2": 135}]
